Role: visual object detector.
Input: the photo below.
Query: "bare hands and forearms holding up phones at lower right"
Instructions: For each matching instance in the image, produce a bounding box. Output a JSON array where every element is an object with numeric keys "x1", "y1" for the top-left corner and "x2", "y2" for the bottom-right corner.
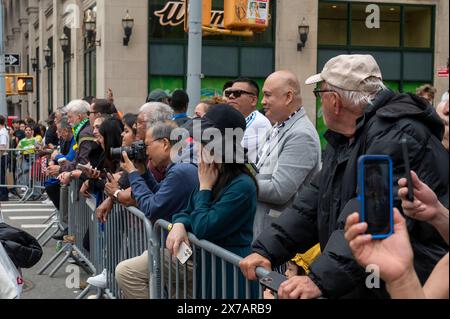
[{"x1": 345, "y1": 172, "x2": 449, "y2": 299}]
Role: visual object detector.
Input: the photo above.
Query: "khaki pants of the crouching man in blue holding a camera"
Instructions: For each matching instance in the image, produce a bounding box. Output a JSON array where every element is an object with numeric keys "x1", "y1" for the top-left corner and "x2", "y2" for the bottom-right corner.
[{"x1": 116, "y1": 249, "x2": 193, "y2": 299}]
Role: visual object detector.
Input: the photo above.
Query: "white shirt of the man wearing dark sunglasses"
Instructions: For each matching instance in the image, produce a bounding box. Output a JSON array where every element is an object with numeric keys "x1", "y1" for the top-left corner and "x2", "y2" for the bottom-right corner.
[{"x1": 242, "y1": 111, "x2": 272, "y2": 163}]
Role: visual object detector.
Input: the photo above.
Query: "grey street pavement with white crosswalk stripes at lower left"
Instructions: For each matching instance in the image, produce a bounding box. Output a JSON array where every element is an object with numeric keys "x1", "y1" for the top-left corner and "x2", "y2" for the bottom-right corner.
[{"x1": 0, "y1": 201, "x2": 94, "y2": 299}]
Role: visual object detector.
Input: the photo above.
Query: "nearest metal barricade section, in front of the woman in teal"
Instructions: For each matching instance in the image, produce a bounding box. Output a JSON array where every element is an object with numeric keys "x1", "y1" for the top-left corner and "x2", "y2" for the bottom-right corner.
[{"x1": 153, "y1": 220, "x2": 269, "y2": 299}]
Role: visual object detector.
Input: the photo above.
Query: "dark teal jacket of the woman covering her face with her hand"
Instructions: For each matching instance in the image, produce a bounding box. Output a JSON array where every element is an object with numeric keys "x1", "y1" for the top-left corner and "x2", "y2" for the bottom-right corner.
[{"x1": 172, "y1": 174, "x2": 257, "y2": 298}]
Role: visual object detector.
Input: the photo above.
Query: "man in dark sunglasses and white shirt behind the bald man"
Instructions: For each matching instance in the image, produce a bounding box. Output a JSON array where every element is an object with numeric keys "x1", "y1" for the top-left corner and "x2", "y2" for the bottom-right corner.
[{"x1": 224, "y1": 78, "x2": 272, "y2": 163}]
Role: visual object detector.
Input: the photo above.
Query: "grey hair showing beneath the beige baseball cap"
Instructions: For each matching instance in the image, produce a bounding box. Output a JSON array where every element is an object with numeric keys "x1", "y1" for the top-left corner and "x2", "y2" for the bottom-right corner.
[{"x1": 327, "y1": 77, "x2": 386, "y2": 111}]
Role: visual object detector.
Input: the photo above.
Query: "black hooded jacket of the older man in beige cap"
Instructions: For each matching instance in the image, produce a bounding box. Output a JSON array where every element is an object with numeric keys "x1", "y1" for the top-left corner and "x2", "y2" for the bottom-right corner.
[{"x1": 254, "y1": 90, "x2": 449, "y2": 298}]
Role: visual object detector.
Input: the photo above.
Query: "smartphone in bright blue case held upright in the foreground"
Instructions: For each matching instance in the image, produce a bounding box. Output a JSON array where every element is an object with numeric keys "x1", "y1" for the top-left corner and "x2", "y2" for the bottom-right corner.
[{"x1": 358, "y1": 155, "x2": 394, "y2": 238}]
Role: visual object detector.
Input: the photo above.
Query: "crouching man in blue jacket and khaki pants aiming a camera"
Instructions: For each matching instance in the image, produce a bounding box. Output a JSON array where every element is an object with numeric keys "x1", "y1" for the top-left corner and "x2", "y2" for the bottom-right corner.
[{"x1": 116, "y1": 121, "x2": 198, "y2": 299}]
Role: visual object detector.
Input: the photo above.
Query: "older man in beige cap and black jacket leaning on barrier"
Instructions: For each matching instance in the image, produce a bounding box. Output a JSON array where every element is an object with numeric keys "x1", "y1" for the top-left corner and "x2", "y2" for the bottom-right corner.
[{"x1": 240, "y1": 55, "x2": 449, "y2": 299}]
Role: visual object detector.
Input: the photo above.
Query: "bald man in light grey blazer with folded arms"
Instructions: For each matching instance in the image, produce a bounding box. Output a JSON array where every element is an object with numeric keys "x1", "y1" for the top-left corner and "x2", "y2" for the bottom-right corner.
[{"x1": 253, "y1": 71, "x2": 321, "y2": 240}]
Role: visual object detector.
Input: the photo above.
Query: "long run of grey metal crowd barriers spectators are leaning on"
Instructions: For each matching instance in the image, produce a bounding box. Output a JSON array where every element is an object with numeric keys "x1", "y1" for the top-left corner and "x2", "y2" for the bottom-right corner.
[{"x1": 38, "y1": 182, "x2": 282, "y2": 299}]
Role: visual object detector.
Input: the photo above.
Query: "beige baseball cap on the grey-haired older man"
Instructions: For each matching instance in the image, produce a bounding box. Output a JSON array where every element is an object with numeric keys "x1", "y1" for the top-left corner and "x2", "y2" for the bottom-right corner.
[{"x1": 305, "y1": 54, "x2": 383, "y2": 91}]
